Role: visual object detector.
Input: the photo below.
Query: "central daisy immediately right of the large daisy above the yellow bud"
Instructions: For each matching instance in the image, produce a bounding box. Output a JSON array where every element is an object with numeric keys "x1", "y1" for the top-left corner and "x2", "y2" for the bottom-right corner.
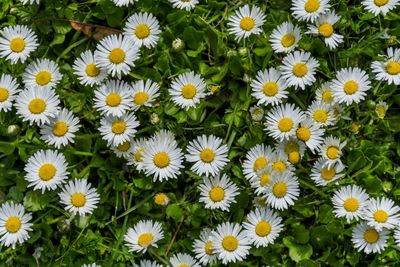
[{"x1": 186, "y1": 134, "x2": 229, "y2": 176}]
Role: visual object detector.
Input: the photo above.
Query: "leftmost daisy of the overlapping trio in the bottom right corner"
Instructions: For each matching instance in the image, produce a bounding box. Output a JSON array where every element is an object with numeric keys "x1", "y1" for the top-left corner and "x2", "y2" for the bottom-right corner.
[{"x1": 332, "y1": 185, "x2": 369, "y2": 223}]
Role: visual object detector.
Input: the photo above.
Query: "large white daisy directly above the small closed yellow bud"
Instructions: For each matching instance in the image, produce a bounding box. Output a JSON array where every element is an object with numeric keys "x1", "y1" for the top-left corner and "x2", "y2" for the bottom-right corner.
[{"x1": 142, "y1": 132, "x2": 184, "y2": 182}]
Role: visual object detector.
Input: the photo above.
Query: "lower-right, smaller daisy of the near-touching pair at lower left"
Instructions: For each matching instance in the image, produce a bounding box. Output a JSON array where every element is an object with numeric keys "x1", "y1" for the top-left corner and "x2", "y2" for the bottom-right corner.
[{"x1": 58, "y1": 179, "x2": 100, "y2": 216}]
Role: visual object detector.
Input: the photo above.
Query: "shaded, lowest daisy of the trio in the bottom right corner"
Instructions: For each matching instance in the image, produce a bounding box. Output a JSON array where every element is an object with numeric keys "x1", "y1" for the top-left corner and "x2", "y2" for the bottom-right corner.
[{"x1": 351, "y1": 222, "x2": 389, "y2": 254}]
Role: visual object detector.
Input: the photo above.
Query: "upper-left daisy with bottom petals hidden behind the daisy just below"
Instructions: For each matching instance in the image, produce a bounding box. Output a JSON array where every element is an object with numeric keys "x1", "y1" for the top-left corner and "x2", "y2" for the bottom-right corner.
[{"x1": 22, "y1": 58, "x2": 62, "y2": 88}]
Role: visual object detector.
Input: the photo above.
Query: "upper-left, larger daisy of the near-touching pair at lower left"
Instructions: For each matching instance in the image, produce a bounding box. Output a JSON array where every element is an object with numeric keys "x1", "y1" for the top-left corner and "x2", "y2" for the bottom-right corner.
[{"x1": 24, "y1": 150, "x2": 69, "y2": 194}]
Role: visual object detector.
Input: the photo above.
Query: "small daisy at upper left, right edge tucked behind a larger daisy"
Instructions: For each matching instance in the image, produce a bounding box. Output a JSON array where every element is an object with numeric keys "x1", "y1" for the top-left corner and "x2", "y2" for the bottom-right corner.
[{"x1": 72, "y1": 50, "x2": 107, "y2": 86}]
